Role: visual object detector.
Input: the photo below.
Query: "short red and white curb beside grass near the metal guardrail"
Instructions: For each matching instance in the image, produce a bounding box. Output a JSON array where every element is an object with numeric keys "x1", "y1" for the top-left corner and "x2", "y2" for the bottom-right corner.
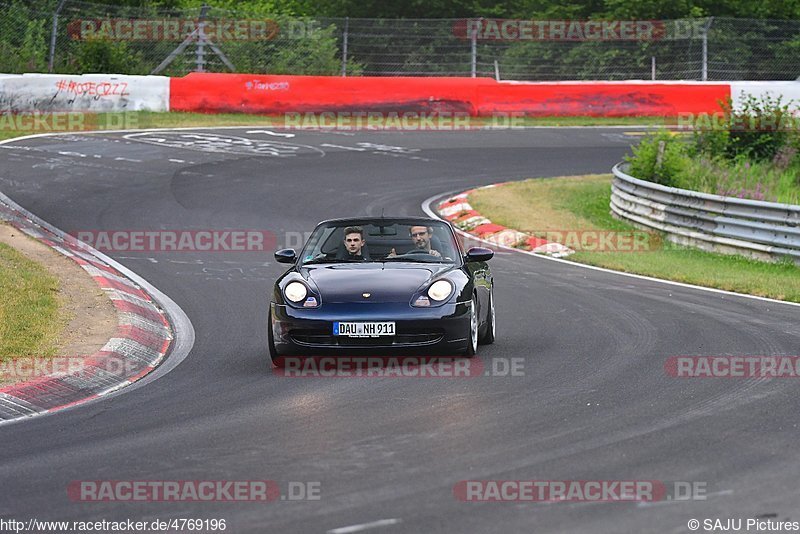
[{"x1": 436, "y1": 184, "x2": 575, "y2": 258}]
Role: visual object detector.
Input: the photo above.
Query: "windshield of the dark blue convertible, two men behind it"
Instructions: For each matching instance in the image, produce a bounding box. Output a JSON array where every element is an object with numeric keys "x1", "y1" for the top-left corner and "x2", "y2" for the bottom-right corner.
[{"x1": 301, "y1": 219, "x2": 459, "y2": 265}]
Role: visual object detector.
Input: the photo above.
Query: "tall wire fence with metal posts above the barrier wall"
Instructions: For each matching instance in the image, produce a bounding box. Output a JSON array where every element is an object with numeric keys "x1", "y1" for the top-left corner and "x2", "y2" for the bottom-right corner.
[{"x1": 0, "y1": 0, "x2": 800, "y2": 81}]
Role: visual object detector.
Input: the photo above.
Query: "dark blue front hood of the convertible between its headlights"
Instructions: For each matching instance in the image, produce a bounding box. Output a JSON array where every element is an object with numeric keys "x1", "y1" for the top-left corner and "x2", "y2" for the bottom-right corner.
[{"x1": 301, "y1": 262, "x2": 453, "y2": 303}]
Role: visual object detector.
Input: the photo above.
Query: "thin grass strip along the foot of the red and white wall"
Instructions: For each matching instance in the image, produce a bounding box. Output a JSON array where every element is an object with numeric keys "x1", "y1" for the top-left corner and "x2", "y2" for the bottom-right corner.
[{"x1": 0, "y1": 111, "x2": 665, "y2": 140}]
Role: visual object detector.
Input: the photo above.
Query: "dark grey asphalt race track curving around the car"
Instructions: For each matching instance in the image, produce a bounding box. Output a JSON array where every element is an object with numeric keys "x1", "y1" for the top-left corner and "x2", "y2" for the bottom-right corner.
[{"x1": 0, "y1": 127, "x2": 800, "y2": 533}]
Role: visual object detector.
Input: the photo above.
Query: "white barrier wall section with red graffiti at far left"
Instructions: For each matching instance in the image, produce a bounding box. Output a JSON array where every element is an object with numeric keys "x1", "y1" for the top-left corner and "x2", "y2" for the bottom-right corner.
[{"x1": 0, "y1": 74, "x2": 169, "y2": 112}]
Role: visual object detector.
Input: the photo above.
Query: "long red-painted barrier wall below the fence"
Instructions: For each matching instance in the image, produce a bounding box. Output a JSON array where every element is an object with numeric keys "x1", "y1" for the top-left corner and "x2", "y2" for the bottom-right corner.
[{"x1": 170, "y1": 73, "x2": 731, "y2": 117}]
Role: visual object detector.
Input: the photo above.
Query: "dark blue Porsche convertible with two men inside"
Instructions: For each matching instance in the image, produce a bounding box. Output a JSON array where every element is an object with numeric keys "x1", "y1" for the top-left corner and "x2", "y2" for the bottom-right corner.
[{"x1": 267, "y1": 217, "x2": 495, "y2": 363}]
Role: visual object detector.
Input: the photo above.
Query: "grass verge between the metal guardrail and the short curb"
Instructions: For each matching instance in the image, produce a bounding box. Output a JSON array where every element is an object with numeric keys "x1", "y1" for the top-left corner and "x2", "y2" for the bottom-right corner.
[{"x1": 469, "y1": 175, "x2": 800, "y2": 302}]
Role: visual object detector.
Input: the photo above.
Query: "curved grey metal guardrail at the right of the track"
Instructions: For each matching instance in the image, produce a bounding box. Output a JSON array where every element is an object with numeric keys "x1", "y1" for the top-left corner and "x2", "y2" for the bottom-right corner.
[{"x1": 611, "y1": 163, "x2": 800, "y2": 264}]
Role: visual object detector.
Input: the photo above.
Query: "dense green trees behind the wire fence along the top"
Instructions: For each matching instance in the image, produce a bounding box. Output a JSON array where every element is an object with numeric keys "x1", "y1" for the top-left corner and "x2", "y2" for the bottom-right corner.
[{"x1": 0, "y1": 0, "x2": 800, "y2": 76}]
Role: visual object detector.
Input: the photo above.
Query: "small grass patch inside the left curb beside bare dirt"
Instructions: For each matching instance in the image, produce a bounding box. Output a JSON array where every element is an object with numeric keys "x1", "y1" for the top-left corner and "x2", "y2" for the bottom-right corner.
[{"x1": 0, "y1": 239, "x2": 63, "y2": 361}]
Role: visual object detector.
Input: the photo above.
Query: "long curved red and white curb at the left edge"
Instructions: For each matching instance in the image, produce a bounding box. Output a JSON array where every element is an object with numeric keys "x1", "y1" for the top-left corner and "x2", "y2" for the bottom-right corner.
[{"x1": 0, "y1": 196, "x2": 174, "y2": 422}]
